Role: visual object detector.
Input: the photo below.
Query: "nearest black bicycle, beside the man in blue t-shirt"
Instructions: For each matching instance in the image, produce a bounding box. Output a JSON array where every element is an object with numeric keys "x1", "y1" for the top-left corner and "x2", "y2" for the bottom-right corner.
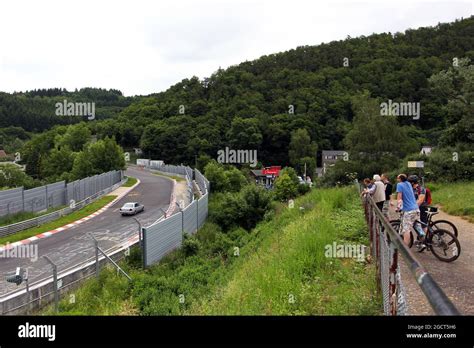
[{"x1": 390, "y1": 211, "x2": 461, "y2": 262}]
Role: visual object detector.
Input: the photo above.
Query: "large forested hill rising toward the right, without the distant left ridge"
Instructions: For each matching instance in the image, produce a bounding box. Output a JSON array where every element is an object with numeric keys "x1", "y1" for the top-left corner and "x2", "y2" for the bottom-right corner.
[{"x1": 107, "y1": 17, "x2": 474, "y2": 164}]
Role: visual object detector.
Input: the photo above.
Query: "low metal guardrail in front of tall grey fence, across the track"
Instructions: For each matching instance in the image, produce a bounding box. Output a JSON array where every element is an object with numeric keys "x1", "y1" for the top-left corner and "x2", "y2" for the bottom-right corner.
[{"x1": 0, "y1": 180, "x2": 125, "y2": 237}]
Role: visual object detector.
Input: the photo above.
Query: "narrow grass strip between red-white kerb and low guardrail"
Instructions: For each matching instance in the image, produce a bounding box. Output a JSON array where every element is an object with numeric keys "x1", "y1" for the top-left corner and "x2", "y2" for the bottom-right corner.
[{"x1": 0, "y1": 195, "x2": 117, "y2": 245}]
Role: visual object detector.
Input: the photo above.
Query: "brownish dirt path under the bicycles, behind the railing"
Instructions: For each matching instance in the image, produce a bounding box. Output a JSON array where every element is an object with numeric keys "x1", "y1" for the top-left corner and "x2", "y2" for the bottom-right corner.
[{"x1": 392, "y1": 205, "x2": 474, "y2": 315}]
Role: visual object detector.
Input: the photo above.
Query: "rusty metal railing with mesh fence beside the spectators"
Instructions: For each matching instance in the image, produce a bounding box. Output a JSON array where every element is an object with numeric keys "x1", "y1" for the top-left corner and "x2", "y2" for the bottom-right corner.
[{"x1": 363, "y1": 196, "x2": 460, "y2": 315}]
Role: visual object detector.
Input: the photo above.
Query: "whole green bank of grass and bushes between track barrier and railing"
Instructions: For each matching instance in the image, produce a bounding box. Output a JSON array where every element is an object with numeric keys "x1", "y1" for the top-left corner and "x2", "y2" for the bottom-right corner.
[{"x1": 47, "y1": 189, "x2": 381, "y2": 315}]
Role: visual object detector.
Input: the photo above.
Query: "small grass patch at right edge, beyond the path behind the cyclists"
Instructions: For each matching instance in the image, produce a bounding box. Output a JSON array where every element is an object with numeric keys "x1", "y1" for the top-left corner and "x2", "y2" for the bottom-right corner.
[{"x1": 426, "y1": 181, "x2": 474, "y2": 222}]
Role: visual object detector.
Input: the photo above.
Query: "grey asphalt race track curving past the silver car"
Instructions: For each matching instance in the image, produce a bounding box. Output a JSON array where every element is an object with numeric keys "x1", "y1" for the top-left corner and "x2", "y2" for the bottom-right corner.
[{"x1": 0, "y1": 168, "x2": 173, "y2": 296}]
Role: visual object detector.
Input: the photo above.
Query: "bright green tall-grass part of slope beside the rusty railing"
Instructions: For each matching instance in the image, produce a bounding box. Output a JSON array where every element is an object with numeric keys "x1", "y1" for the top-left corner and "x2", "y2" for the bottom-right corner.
[{"x1": 187, "y1": 189, "x2": 380, "y2": 315}]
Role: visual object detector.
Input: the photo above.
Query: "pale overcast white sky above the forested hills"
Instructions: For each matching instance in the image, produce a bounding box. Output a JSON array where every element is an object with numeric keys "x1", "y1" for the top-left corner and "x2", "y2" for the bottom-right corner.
[{"x1": 0, "y1": 0, "x2": 474, "y2": 96}]
